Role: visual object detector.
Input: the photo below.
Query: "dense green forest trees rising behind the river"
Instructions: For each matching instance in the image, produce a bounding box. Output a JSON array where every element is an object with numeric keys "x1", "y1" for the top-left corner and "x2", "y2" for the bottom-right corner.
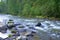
[{"x1": 0, "y1": 0, "x2": 60, "y2": 18}]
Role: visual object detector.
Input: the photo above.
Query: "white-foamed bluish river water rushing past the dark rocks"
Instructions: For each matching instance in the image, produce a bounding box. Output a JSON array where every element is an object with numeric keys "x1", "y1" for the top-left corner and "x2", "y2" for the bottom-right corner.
[{"x1": 0, "y1": 15, "x2": 60, "y2": 40}]
